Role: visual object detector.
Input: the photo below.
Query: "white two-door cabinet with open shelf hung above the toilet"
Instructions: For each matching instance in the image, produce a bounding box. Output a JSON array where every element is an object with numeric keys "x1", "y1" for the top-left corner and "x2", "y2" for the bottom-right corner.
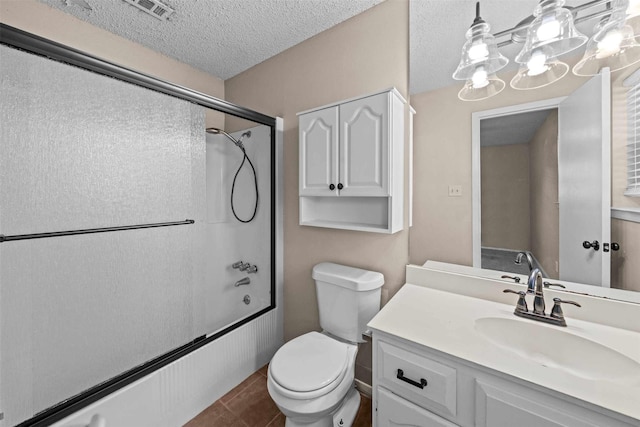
[{"x1": 298, "y1": 89, "x2": 406, "y2": 233}]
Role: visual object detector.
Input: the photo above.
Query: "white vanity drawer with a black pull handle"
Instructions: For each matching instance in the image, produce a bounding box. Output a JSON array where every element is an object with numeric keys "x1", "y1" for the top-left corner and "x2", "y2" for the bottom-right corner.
[{"x1": 375, "y1": 341, "x2": 456, "y2": 417}]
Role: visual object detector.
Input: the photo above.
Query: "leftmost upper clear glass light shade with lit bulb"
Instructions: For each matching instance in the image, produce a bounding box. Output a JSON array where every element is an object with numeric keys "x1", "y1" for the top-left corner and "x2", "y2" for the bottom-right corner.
[{"x1": 453, "y1": 20, "x2": 509, "y2": 80}]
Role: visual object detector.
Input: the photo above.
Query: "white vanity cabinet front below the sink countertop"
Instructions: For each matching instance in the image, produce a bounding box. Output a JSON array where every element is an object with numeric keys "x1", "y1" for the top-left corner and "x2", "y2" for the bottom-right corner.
[{"x1": 373, "y1": 330, "x2": 637, "y2": 427}]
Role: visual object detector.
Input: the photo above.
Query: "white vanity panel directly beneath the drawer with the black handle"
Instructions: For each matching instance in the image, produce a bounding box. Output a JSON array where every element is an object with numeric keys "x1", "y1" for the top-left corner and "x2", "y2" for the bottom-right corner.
[{"x1": 375, "y1": 387, "x2": 455, "y2": 427}]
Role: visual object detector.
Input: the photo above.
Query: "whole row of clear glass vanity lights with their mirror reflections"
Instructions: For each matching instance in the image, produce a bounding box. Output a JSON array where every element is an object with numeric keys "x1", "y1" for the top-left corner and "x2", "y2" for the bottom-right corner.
[{"x1": 453, "y1": 0, "x2": 640, "y2": 101}]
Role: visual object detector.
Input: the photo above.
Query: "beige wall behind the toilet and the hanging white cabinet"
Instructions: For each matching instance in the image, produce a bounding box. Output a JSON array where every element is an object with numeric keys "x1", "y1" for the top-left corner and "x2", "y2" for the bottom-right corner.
[{"x1": 225, "y1": 0, "x2": 409, "y2": 384}]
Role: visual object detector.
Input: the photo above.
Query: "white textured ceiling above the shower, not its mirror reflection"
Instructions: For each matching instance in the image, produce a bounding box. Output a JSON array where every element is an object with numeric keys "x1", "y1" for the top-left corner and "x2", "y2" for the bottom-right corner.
[{"x1": 39, "y1": 0, "x2": 383, "y2": 80}]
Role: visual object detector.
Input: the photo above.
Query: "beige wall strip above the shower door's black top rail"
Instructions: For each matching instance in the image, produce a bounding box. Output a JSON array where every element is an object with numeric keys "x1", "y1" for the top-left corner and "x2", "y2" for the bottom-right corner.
[{"x1": 0, "y1": 0, "x2": 224, "y2": 127}]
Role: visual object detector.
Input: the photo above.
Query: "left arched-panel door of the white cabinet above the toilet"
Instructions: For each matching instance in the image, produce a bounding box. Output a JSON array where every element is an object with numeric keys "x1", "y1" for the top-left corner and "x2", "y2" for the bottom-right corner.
[{"x1": 298, "y1": 107, "x2": 338, "y2": 196}]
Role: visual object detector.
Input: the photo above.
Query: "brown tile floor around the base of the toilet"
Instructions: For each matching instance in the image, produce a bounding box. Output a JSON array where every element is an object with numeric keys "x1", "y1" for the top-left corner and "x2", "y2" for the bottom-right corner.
[{"x1": 184, "y1": 366, "x2": 371, "y2": 427}]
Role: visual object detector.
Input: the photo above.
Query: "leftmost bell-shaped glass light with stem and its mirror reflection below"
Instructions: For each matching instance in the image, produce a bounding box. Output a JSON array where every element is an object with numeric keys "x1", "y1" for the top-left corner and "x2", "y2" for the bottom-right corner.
[{"x1": 453, "y1": 2, "x2": 509, "y2": 101}]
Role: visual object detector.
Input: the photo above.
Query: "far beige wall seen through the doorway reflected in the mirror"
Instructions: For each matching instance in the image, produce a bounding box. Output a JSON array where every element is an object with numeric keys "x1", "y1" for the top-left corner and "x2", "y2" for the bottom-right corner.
[{"x1": 480, "y1": 144, "x2": 531, "y2": 251}]
